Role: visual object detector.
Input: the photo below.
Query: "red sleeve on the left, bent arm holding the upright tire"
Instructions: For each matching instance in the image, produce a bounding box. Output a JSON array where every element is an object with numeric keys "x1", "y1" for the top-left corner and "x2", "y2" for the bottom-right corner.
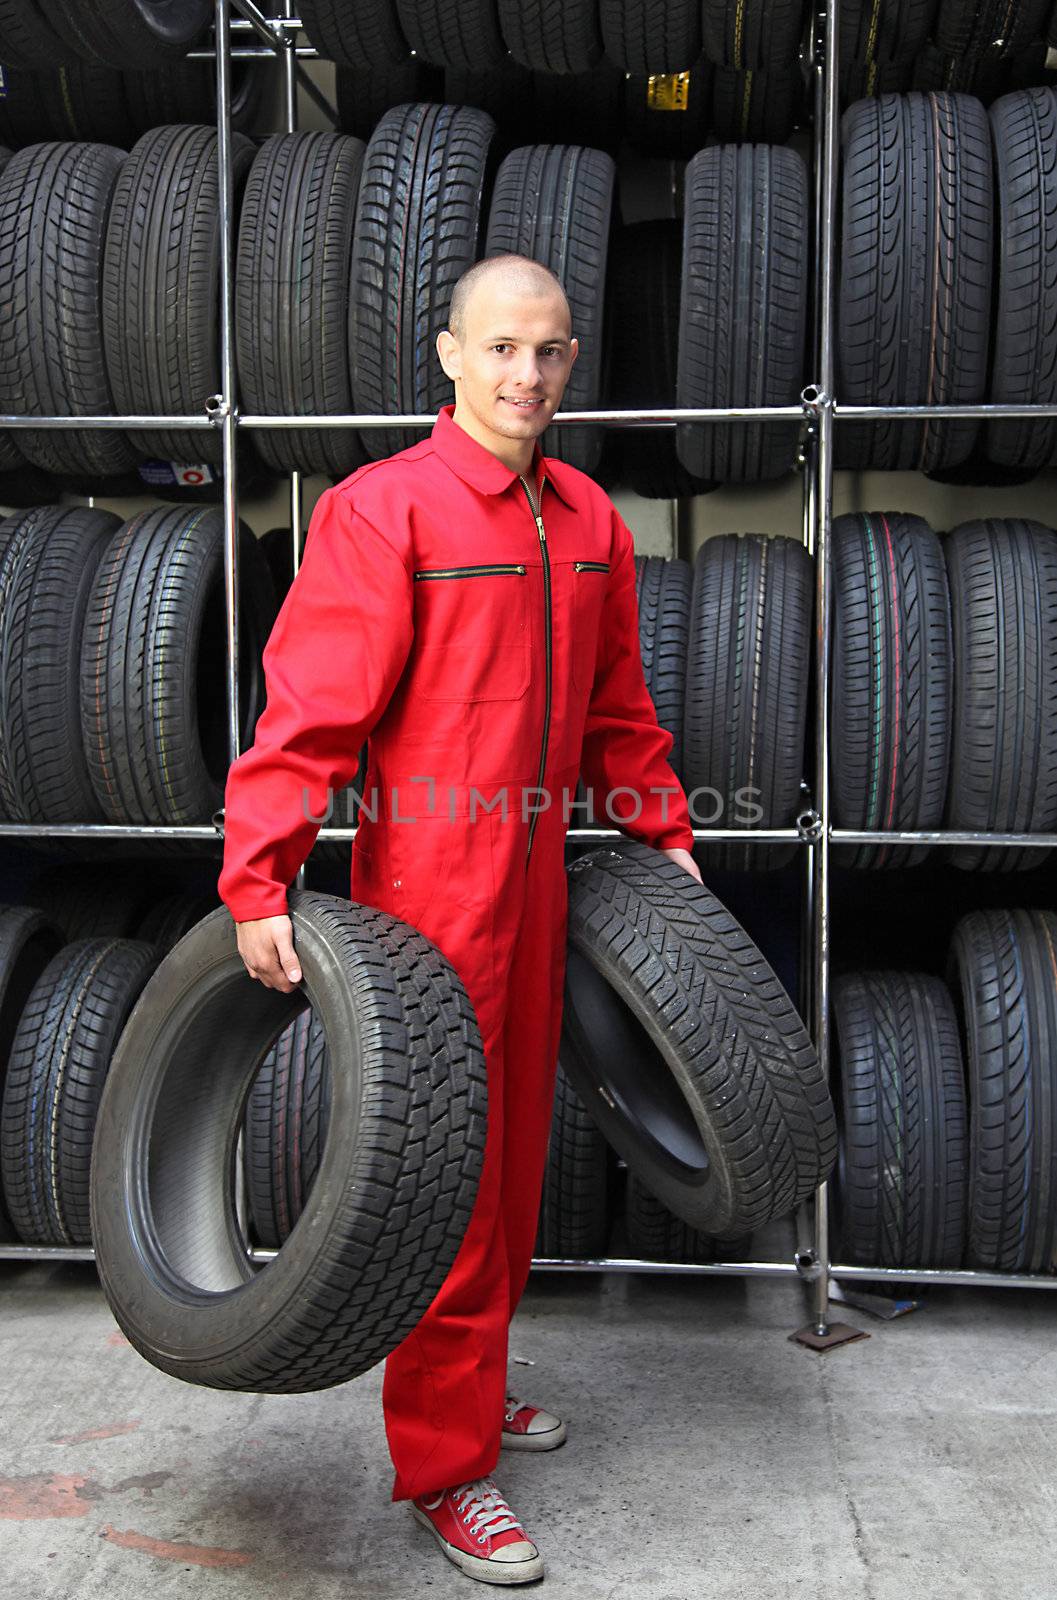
[{"x1": 217, "y1": 488, "x2": 414, "y2": 922}]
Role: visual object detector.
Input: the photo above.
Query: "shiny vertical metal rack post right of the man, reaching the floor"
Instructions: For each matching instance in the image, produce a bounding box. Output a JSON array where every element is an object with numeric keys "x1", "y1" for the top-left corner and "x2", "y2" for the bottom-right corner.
[{"x1": 809, "y1": 0, "x2": 840, "y2": 1336}]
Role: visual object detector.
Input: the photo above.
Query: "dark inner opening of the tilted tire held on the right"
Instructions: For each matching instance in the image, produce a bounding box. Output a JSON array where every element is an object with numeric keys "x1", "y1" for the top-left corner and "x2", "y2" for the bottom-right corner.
[{"x1": 563, "y1": 949, "x2": 708, "y2": 1182}]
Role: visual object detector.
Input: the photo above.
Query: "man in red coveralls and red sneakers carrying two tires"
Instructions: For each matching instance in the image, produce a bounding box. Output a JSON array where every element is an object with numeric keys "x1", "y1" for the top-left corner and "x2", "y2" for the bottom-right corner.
[{"x1": 219, "y1": 256, "x2": 700, "y2": 1584}]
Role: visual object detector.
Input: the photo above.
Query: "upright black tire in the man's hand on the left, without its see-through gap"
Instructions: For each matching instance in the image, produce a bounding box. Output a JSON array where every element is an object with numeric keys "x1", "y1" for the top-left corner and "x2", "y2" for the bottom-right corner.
[{"x1": 91, "y1": 890, "x2": 486, "y2": 1394}]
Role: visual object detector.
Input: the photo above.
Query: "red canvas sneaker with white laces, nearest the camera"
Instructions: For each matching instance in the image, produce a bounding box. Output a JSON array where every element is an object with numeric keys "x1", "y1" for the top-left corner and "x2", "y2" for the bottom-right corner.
[{"x1": 411, "y1": 1478, "x2": 544, "y2": 1584}]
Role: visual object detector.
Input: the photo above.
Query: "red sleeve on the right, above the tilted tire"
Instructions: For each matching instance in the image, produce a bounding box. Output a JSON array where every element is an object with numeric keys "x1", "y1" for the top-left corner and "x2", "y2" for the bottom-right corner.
[{"x1": 580, "y1": 509, "x2": 694, "y2": 850}]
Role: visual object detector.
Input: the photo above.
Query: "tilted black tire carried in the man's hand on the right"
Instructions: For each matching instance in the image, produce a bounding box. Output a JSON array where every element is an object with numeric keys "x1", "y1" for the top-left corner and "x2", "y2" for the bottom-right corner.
[{"x1": 561, "y1": 840, "x2": 836, "y2": 1235}]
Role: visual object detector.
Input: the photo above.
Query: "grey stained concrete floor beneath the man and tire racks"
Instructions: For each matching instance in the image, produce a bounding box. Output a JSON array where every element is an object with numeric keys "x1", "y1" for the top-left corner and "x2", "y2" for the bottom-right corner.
[{"x1": 0, "y1": 1235, "x2": 1057, "y2": 1600}]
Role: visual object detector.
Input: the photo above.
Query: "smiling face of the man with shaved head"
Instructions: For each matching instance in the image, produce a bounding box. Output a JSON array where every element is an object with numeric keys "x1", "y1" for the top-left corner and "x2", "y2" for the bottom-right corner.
[{"x1": 438, "y1": 278, "x2": 577, "y2": 443}]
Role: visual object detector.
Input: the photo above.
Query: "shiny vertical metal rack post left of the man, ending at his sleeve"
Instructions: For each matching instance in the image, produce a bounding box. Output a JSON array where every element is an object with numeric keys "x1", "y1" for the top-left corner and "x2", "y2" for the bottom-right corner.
[{"x1": 214, "y1": 0, "x2": 240, "y2": 762}]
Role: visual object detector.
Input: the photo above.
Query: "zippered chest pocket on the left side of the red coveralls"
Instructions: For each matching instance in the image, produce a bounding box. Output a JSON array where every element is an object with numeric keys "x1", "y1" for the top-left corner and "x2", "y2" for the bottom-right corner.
[{"x1": 411, "y1": 562, "x2": 532, "y2": 702}]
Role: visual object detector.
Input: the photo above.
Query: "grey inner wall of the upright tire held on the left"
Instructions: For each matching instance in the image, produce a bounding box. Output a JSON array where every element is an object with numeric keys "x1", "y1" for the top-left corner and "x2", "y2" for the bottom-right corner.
[{"x1": 133, "y1": 971, "x2": 309, "y2": 1294}]
